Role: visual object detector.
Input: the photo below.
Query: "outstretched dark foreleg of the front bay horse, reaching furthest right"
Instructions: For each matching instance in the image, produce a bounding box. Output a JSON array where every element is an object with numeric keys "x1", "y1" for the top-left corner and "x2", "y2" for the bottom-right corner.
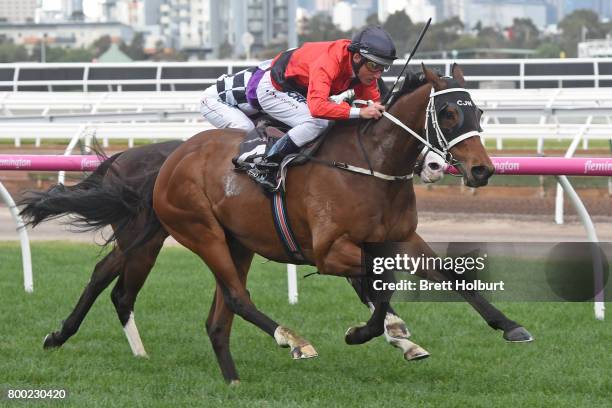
[{"x1": 410, "y1": 233, "x2": 533, "y2": 342}]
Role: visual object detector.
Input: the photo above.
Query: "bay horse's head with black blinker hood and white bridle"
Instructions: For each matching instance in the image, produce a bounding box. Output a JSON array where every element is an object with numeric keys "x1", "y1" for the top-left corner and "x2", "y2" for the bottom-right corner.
[{"x1": 422, "y1": 64, "x2": 495, "y2": 187}]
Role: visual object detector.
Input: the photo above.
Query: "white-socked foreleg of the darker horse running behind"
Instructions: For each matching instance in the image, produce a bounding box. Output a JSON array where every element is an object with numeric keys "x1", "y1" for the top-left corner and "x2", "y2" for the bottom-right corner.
[{"x1": 348, "y1": 278, "x2": 429, "y2": 361}]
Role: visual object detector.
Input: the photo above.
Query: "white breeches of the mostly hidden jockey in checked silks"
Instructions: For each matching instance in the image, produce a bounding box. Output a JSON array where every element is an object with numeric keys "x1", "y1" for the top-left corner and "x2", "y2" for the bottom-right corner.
[{"x1": 200, "y1": 84, "x2": 258, "y2": 131}]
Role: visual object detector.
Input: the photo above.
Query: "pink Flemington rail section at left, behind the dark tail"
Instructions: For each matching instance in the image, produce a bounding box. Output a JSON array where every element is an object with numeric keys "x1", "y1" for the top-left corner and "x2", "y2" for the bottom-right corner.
[{"x1": 0, "y1": 154, "x2": 100, "y2": 171}]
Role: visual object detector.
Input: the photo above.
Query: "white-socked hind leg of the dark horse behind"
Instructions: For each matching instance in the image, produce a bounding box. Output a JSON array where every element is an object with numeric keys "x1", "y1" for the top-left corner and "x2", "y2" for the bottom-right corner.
[{"x1": 111, "y1": 230, "x2": 168, "y2": 357}]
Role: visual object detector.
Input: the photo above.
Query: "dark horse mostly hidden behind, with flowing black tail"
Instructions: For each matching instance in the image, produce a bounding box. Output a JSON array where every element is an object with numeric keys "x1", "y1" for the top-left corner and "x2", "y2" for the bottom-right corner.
[{"x1": 19, "y1": 141, "x2": 429, "y2": 360}]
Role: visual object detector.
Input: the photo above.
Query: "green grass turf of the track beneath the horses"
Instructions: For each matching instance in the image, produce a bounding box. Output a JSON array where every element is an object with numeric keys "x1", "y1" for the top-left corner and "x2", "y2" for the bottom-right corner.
[{"x1": 0, "y1": 243, "x2": 612, "y2": 407}]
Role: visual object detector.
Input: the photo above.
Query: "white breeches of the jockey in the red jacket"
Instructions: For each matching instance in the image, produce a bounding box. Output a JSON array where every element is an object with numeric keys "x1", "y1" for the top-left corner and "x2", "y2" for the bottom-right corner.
[{"x1": 257, "y1": 71, "x2": 330, "y2": 146}]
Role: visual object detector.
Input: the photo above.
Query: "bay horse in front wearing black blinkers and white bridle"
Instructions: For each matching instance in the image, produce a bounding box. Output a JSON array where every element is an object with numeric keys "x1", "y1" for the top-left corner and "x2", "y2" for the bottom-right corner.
[{"x1": 153, "y1": 66, "x2": 531, "y2": 383}]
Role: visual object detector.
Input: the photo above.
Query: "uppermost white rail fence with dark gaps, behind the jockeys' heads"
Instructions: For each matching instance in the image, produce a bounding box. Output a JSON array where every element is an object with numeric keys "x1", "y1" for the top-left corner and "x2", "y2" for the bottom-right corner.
[{"x1": 0, "y1": 58, "x2": 612, "y2": 91}]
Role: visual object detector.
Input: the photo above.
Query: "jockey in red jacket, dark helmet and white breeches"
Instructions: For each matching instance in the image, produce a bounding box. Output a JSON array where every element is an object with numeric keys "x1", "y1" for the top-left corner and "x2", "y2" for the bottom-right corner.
[{"x1": 257, "y1": 26, "x2": 397, "y2": 188}]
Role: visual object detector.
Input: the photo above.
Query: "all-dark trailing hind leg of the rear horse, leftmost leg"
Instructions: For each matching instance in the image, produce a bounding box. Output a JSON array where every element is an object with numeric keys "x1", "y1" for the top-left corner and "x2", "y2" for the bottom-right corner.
[{"x1": 43, "y1": 248, "x2": 123, "y2": 349}]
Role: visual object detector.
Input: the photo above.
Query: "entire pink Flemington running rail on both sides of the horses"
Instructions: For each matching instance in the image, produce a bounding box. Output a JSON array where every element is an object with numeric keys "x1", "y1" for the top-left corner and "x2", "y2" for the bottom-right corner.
[{"x1": 0, "y1": 154, "x2": 612, "y2": 176}]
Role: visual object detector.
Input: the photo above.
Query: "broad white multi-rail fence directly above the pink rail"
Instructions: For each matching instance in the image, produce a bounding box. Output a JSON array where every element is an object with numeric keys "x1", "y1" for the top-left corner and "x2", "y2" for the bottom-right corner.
[{"x1": 0, "y1": 89, "x2": 612, "y2": 153}]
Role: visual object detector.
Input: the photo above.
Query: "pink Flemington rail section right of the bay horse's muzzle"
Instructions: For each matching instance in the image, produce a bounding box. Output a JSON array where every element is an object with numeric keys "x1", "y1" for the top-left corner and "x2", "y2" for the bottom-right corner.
[{"x1": 447, "y1": 157, "x2": 612, "y2": 176}]
